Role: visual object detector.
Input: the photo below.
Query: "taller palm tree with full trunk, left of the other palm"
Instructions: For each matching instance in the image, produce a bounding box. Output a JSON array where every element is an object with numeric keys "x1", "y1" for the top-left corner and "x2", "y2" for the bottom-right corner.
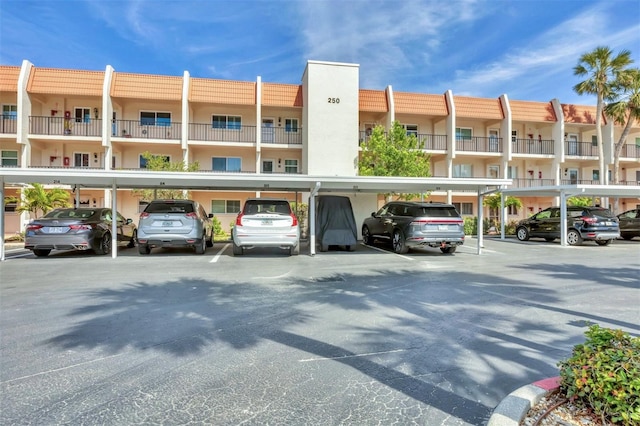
[{"x1": 573, "y1": 46, "x2": 633, "y2": 184}]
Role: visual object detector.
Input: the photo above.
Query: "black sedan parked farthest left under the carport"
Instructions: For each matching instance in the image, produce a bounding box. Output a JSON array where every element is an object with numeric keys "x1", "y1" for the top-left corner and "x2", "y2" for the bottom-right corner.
[{"x1": 24, "y1": 208, "x2": 137, "y2": 256}]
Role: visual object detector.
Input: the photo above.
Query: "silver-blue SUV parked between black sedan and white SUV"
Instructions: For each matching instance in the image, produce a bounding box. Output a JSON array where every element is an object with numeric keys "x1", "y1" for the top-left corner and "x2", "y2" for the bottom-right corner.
[{"x1": 138, "y1": 200, "x2": 214, "y2": 254}]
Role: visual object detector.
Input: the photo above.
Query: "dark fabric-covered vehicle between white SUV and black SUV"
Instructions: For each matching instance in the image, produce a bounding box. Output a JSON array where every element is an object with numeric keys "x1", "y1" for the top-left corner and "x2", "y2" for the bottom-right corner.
[{"x1": 316, "y1": 195, "x2": 358, "y2": 246}]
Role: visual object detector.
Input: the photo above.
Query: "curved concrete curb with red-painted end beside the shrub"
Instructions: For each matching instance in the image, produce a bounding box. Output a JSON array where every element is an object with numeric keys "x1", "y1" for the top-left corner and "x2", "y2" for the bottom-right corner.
[{"x1": 487, "y1": 377, "x2": 560, "y2": 426}]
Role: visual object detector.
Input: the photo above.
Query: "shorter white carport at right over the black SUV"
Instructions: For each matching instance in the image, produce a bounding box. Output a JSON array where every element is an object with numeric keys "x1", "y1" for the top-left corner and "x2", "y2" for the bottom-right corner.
[{"x1": 500, "y1": 184, "x2": 640, "y2": 246}]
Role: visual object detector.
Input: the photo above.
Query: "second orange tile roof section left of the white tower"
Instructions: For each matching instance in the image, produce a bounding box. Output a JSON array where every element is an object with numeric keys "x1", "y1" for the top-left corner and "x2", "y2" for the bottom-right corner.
[{"x1": 189, "y1": 78, "x2": 256, "y2": 105}]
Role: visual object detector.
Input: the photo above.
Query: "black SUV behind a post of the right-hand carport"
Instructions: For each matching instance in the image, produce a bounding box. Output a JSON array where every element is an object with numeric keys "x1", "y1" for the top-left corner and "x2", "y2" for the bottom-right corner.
[{"x1": 516, "y1": 206, "x2": 620, "y2": 246}]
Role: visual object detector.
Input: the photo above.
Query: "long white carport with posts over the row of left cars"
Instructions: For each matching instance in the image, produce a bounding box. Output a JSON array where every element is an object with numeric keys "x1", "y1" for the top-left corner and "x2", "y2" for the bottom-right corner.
[{"x1": 0, "y1": 168, "x2": 511, "y2": 261}]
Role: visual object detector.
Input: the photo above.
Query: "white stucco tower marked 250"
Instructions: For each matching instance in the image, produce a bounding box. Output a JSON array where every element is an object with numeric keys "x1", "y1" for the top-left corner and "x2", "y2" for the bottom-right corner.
[{"x1": 302, "y1": 61, "x2": 360, "y2": 176}]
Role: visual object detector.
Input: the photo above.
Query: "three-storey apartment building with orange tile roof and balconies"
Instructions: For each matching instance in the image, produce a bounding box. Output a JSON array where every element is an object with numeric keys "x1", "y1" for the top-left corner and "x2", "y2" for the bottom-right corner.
[{"x1": 0, "y1": 60, "x2": 640, "y2": 234}]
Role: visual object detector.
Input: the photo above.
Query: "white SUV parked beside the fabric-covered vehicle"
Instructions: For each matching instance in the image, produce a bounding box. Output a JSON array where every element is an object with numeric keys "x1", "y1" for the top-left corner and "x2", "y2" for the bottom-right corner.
[{"x1": 232, "y1": 198, "x2": 300, "y2": 256}]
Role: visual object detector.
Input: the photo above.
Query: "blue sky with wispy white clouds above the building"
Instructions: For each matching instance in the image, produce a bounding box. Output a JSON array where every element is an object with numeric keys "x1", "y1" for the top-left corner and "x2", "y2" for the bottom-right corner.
[{"x1": 0, "y1": 0, "x2": 640, "y2": 105}]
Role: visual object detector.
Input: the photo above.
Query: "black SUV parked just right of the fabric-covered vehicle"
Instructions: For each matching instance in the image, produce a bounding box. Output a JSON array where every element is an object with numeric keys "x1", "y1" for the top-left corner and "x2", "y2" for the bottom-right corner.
[{"x1": 362, "y1": 201, "x2": 464, "y2": 253}]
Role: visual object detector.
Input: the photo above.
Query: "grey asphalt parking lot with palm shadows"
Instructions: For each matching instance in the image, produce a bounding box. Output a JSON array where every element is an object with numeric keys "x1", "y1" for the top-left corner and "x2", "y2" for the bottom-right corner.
[{"x1": 0, "y1": 238, "x2": 640, "y2": 425}]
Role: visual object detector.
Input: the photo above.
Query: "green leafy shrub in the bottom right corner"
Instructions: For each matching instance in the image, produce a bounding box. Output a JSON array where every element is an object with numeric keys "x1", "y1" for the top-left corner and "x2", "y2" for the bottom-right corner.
[{"x1": 558, "y1": 325, "x2": 640, "y2": 425}]
